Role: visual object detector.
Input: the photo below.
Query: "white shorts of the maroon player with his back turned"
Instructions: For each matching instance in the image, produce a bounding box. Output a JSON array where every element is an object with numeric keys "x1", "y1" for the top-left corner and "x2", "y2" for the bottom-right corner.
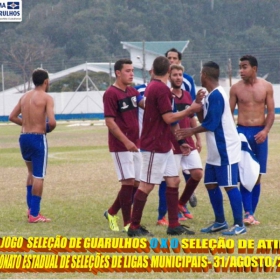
[{"x1": 141, "y1": 150, "x2": 179, "y2": 185}]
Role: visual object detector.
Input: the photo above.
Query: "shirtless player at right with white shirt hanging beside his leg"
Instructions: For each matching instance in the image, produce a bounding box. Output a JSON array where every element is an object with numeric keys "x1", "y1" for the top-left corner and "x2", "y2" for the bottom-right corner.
[{"x1": 230, "y1": 55, "x2": 274, "y2": 225}]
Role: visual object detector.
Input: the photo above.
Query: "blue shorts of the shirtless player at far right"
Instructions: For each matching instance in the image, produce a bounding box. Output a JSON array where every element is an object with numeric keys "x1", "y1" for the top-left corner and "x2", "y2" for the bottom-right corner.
[{"x1": 237, "y1": 125, "x2": 268, "y2": 174}]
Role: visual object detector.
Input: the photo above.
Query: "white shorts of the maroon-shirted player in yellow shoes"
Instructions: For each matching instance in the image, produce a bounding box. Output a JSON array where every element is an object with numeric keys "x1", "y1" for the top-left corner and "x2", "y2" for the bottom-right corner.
[{"x1": 111, "y1": 152, "x2": 142, "y2": 181}]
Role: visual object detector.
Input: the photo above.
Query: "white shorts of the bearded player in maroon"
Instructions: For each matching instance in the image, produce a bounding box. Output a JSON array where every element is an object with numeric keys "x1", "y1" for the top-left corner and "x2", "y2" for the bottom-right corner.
[{"x1": 174, "y1": 150, "x2": 202, "y2": 174}]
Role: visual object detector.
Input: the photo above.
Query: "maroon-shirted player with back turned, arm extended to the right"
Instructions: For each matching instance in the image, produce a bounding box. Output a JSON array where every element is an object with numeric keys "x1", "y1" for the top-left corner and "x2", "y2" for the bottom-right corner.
[{"x1": 127, "y1": 56, "x2": 202, "y2": 237}]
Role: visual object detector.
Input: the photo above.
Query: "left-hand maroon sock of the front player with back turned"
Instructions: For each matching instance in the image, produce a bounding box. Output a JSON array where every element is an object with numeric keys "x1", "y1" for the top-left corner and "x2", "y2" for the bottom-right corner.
[{"x1": 130, "y1": 189, "x2": 149, "y2": 229}]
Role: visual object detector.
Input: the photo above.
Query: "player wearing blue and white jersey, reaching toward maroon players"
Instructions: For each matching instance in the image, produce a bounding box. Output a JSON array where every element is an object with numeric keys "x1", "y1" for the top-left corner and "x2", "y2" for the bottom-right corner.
[{"x1": 177, "y1": 61, "x2": 246, "y2": 236}]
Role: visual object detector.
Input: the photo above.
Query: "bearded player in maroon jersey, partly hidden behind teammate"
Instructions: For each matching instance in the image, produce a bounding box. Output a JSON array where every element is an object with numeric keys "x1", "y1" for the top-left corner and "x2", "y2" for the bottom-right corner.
[{"x1": 169, "y1": 64, "x2": 203, "y2": 221}]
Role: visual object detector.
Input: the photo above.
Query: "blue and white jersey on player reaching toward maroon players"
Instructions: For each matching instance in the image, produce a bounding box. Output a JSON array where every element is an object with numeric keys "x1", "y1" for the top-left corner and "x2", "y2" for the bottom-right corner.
[{"x1": 201, "y1": 86, "x2": 241, "y2": 166}]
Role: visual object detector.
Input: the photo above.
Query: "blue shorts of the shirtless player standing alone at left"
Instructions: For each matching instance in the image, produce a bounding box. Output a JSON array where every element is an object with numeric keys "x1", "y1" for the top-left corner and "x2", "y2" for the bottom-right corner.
[{"x1": 19, "y1": 133, "x2": 48, "y2": 179}]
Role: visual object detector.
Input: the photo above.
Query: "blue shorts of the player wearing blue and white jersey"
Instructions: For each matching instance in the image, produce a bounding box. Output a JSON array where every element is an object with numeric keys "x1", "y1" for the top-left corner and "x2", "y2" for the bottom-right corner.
[{"x1": 204, "y1": 163, "x2": 238, "y2": 187}]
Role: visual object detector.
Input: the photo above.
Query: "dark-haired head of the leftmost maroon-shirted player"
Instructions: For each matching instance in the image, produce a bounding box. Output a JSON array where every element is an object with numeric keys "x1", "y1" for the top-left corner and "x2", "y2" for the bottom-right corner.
[{"x1": 114, "y1": 58, "x2": 134, "y2": 85}]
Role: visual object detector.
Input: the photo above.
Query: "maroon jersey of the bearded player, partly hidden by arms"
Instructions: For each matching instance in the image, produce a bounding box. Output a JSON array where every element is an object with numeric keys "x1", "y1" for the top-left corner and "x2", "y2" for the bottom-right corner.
[{"x1": 171, "y1": 90, "x2": 195, "y2": 154}]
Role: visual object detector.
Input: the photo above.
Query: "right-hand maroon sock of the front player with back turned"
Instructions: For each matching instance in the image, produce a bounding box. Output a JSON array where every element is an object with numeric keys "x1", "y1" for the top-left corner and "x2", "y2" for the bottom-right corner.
[{"x1": 166, "y1": 187, "x2": 180, "y2": 228}]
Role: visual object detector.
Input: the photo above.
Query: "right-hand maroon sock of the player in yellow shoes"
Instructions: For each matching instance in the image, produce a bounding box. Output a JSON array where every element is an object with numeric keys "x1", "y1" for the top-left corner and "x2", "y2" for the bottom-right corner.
[{"x1": 119, "y1": 185, "x2": 134, "y2": 226}]
